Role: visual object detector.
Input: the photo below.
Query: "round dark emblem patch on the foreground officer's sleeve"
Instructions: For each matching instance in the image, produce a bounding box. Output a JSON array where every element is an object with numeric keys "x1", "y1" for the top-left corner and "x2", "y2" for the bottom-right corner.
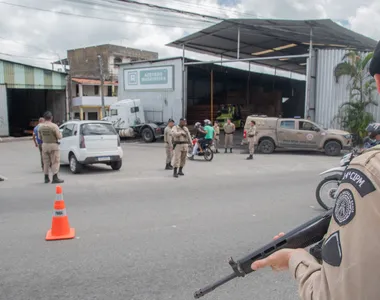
[{"x1": 333, "y1": 189, "x2": 356, "y2": 226}]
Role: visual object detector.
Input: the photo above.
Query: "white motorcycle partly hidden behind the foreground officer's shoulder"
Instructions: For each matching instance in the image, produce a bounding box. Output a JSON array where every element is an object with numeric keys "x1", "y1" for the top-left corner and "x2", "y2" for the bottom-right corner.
[{"x1": 315, "y1": 148, "x2": 359, "y2": 210}]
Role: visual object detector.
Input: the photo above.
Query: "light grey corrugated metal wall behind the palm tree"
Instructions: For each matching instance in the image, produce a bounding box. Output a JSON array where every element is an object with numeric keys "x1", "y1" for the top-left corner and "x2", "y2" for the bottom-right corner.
[{"x1": 315, "y1": 50, "x2": 380, "y2": 129}]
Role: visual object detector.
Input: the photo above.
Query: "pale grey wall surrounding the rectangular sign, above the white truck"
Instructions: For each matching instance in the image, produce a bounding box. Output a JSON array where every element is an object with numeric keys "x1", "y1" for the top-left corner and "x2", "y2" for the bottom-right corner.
[{"x1": 118, "y1": 58, "x2": 186, "y2": 122}]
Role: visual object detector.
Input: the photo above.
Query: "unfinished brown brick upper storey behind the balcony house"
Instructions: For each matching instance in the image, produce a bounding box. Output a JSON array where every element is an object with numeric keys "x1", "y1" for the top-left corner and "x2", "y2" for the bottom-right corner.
[{"x1": 67, "y1": 45, "x2": 158, "y2": 80}]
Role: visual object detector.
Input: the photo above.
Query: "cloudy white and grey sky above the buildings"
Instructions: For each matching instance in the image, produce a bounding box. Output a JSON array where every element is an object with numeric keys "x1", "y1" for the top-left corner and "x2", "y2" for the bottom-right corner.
[{"x1": 0, "y1": 0, "x2": 380, "y2": 78}]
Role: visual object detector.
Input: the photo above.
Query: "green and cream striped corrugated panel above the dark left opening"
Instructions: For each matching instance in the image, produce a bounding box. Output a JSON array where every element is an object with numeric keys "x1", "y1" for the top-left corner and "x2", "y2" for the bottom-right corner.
[{"x1": 0, "y1": 59, "x2": 67, "y2": 90}]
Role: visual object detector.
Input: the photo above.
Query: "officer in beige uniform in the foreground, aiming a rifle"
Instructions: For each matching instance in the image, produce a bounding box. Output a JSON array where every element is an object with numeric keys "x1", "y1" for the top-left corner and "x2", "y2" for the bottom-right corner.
[{"x1": 252, "y1": 44, "x2": 380, "y2": 300}]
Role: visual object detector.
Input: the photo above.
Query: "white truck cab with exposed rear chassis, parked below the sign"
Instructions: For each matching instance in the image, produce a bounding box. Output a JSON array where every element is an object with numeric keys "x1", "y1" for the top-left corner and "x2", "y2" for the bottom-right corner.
[{"x1": 103, "y1": 99, "x2": 167, "y2": 143}]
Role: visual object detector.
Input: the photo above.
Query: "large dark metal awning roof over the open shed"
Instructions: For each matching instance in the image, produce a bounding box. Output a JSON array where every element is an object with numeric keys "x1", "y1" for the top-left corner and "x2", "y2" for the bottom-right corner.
[{"x1": 167, "y1": 19, "x2": 377, "y2": 74}]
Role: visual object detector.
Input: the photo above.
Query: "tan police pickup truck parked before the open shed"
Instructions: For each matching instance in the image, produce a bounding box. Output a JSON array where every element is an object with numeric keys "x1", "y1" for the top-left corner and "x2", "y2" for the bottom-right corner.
[{"x1": 241, "y1": 115, "x2": 352, "y2": 156}]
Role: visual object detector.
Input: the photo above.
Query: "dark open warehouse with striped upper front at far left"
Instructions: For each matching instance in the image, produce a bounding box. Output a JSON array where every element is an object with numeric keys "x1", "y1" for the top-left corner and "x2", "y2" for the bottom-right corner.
[{"x1": 0, "y1": 59, "x2": 67, "y2": 136}]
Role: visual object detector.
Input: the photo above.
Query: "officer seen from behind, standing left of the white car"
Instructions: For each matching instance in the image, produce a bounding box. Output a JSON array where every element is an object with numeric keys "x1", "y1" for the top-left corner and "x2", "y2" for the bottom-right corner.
[{"x1": 38, "y1": 111, "x2": 64, "y2": 183}]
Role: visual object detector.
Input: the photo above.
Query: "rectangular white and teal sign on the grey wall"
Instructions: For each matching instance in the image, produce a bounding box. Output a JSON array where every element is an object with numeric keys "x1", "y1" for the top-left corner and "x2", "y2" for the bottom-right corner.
[{"x1": 124, "y1": 66, "x2": 174, "y2": 91}]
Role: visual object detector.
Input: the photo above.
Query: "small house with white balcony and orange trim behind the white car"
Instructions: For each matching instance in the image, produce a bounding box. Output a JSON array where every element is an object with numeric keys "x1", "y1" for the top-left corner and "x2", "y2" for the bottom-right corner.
[{"x1": 71, "y1": 78, "x2": 118, "y2": 120}]
